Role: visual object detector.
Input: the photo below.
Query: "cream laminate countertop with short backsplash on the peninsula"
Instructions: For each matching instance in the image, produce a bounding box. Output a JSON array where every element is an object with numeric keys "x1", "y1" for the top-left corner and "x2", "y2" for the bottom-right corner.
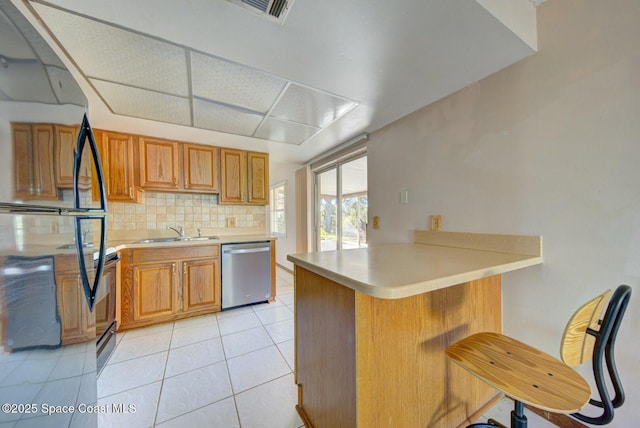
[{"x1": 287, "y1": 231, "x2": 542, "y2": 299}]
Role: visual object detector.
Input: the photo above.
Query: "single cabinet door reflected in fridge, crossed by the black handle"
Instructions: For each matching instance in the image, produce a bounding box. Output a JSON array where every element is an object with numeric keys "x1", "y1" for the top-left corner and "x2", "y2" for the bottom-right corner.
[{"x1": 55, "y1": 125, "x2": 91, "y2": 189}]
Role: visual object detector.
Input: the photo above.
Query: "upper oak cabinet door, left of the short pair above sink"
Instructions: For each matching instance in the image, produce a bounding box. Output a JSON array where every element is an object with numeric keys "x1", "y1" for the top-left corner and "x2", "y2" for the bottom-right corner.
[{"x1": 138, "y1": 137, "x2": 180, "y2": 190}]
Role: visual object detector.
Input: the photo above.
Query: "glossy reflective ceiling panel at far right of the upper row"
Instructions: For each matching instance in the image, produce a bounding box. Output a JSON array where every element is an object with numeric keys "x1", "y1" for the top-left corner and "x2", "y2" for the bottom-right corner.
[{"x1": 271, "y1": 83, "x2": 355, "y2": 128}]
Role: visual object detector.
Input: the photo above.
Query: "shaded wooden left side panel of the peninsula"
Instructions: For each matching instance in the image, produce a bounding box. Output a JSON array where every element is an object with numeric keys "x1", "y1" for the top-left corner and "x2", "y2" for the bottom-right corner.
[{"x1": 295, "y1": 266, "x2": 358, "y2": 427}]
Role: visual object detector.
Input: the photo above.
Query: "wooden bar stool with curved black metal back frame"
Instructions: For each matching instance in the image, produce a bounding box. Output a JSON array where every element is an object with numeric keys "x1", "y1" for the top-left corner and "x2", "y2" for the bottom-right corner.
[{"x1": 445, "y1": 285, "x2": 631, "y2": 428}]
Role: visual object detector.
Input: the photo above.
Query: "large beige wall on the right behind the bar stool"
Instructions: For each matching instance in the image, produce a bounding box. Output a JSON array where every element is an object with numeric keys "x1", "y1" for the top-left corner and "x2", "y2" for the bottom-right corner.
[{"x1": 368, "y1": 0, "x2": 640, "y2": 427}]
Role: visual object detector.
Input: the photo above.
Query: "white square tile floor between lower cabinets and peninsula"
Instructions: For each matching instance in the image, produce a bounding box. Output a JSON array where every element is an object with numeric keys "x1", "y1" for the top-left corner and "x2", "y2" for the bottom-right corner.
[{"x1": 98, "y1": 268, "x2": 555, "y2": 428}]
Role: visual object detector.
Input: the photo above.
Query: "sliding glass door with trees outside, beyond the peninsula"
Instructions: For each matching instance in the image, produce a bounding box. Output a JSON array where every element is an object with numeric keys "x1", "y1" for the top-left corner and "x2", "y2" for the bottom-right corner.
[{"x1": 316, "y1": 156, "x2": 368, "y2": 251}]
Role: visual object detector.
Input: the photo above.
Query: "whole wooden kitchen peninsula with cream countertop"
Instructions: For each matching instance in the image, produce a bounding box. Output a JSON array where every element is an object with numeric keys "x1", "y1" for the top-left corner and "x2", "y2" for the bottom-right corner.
[{"x1": 288, "y1": 231, "x2": 542, "y2": 428}]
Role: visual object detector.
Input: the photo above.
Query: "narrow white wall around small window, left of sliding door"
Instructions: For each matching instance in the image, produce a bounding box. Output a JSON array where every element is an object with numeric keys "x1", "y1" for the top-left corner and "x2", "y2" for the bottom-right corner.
[{"x1": 267, "y1": 159, "x2": 302, "y2": 270}]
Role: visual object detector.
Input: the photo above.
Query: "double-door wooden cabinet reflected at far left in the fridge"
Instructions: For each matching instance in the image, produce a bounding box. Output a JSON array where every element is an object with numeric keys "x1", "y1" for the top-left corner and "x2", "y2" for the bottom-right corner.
[{"x1": 11, "y1": 123, "x2": 58, "y2": 199}]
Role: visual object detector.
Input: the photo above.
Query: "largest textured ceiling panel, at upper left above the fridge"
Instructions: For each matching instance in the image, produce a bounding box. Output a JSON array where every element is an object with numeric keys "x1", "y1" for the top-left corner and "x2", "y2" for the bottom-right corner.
[{"x1": 33, "y1": 3, "x2": 189, "y2": 96}]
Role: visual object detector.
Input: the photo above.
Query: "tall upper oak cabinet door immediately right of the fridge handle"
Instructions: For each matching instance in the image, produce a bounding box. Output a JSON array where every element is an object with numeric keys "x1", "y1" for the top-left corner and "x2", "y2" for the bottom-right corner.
[{"x1": 101, "y1": 132, "x2": 138, "y2": 202}]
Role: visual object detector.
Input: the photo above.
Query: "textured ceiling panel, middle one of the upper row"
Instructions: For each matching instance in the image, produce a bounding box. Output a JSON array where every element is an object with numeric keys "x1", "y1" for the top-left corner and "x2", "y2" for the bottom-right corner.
[{"x1": 191, "y1": 52, "x2": 287, "y2": 113}]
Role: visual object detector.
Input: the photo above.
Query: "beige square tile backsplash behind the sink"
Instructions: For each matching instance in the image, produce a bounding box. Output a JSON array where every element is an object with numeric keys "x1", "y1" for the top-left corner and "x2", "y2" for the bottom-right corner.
[{"x1": 107, "y1": 192, "x2": 266, "y2": 231}]
